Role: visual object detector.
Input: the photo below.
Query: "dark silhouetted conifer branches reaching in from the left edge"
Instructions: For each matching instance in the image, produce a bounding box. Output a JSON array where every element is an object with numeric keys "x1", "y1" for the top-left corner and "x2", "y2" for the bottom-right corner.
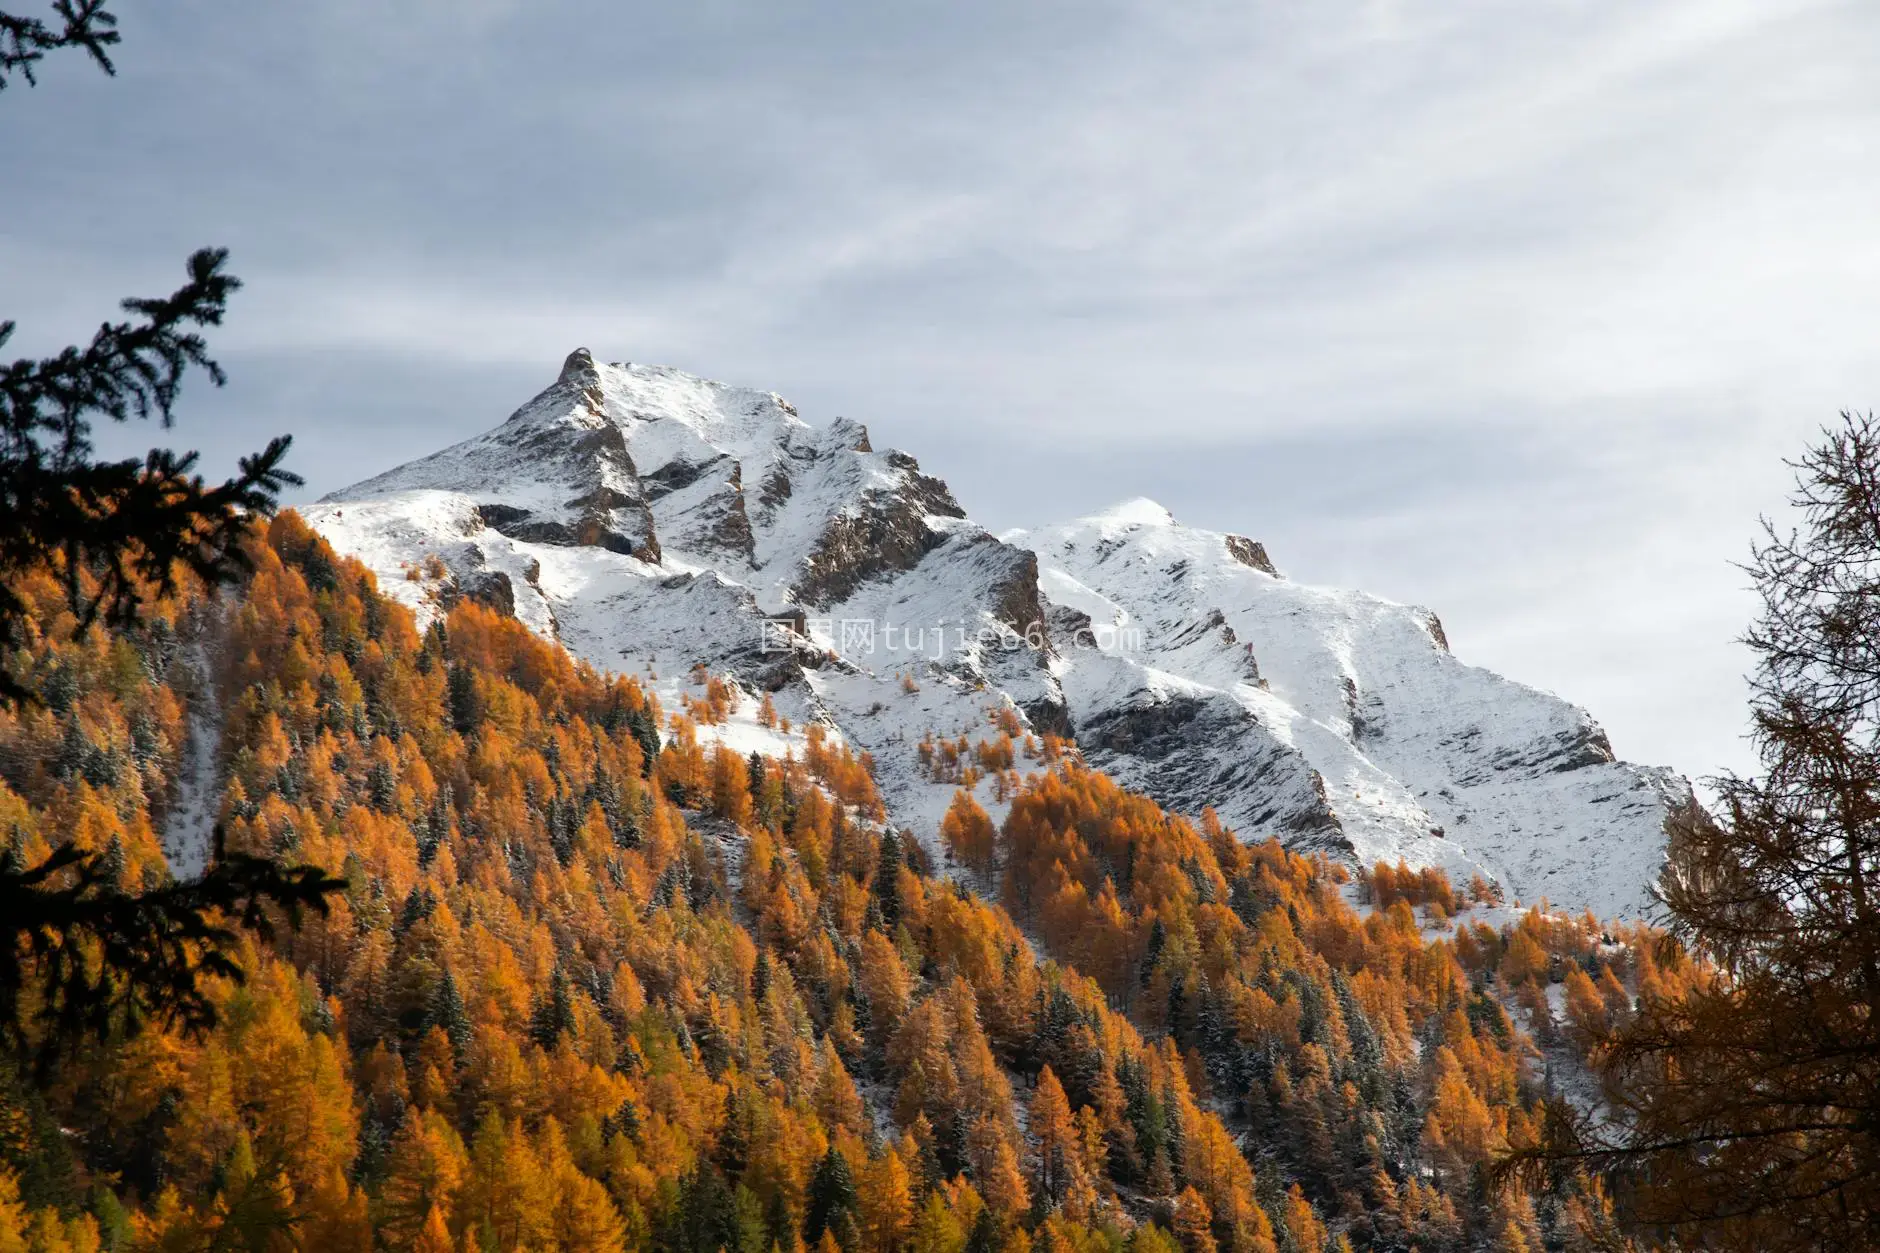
[{"x1": 0, "y1": 0, "x2": 344, "y2": 1071}]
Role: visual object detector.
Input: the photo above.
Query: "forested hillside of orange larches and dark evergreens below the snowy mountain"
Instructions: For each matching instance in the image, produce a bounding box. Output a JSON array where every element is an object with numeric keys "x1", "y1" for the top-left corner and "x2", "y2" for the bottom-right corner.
[{"x1": 0, "y1": 514, "x2": 1676, "y2": 1253}]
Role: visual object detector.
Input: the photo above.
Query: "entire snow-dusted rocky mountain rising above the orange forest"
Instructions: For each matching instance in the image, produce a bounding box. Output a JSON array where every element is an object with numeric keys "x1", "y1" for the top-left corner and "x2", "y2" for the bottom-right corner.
[{"x1": 308, "y1": 350, "x2": 1688, "y2": 914}]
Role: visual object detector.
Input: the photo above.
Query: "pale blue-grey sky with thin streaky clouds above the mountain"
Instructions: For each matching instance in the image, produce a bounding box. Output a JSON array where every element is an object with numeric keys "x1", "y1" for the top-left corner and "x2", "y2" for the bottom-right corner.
[{"x1": 0, "y1": 0, "x2": 1880, "y2": 777}]
